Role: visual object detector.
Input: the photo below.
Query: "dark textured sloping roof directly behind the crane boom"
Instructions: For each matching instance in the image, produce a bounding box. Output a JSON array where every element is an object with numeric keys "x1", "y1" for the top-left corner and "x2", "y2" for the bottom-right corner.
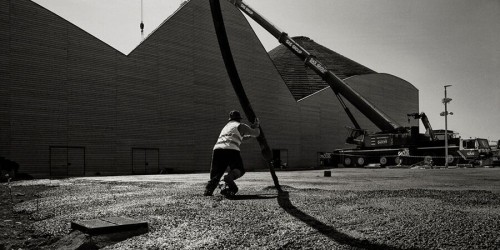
[{"x1": 269, "y1": 36, "x2": 376, "y2": 101}]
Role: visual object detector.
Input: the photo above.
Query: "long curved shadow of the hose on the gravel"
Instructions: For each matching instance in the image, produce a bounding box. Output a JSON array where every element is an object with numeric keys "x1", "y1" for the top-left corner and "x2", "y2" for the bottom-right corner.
[{"x1": 278, "y1": 191, "x2": 414, "y2": 250}]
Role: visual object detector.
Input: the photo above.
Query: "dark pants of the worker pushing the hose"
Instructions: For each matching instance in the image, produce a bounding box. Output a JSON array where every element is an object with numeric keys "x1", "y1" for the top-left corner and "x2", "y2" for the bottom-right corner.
[{"x1": 207, "y1": 149, "x2": 245, "y2": 188}]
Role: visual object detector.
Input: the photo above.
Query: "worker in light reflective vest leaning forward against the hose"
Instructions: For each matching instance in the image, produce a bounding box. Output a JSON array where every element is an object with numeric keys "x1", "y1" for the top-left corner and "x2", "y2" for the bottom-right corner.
[{"x1": 204, "y1": 110, "x2": 260, "y2": 196}]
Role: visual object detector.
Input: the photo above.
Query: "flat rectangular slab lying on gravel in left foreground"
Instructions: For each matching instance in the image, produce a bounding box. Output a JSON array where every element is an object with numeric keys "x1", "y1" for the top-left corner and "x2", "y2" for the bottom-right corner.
[{"x1": 71, "y1": 217, "x2": 148, "y2": 235}]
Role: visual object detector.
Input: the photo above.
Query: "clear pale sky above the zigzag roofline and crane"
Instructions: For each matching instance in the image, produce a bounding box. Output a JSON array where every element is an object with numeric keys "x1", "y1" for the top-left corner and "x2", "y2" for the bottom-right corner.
[{"x1": 34, "y1": 0, "x2": 500, "y2": 143}]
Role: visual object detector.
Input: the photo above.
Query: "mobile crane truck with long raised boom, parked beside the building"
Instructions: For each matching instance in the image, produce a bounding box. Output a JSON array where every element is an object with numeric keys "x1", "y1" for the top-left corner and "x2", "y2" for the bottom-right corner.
[{"x1": 224, "y1": 0, "x2": 491, "y2": 166}]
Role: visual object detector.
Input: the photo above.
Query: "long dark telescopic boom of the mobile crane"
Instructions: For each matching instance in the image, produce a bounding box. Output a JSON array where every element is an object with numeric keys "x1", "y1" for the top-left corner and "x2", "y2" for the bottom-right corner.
[{"x1": 228, "y1": 0, "x2": 403, "y2": 132}]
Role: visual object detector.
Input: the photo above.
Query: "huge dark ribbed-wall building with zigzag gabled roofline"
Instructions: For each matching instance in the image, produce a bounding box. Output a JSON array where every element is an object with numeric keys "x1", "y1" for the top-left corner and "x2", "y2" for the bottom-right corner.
[{"x1": 0, "y1": 0, "x2": 418, "y2": 177}]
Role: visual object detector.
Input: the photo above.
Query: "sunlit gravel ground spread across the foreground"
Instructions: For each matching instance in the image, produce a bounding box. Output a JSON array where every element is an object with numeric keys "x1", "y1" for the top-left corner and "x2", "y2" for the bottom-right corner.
[{"x1": 0, "y1": 168, "x2": 500, "y2": 249}]
